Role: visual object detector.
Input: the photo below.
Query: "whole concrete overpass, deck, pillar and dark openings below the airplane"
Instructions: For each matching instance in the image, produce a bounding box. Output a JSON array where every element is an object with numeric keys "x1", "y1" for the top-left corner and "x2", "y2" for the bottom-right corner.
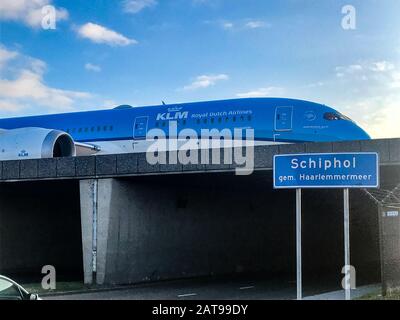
[{"x1": 0, "y1": 139, "x2": 400, "y2": 292}]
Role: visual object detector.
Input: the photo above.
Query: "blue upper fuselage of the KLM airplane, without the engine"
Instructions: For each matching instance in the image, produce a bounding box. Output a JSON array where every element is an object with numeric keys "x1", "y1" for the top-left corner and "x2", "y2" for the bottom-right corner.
[{"x1": 0, "y1": 98, "x2": 370, "y2": 156}]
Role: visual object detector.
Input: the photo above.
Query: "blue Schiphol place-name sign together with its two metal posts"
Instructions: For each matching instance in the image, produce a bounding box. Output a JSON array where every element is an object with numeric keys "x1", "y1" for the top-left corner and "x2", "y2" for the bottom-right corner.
[{"x1": 273, "y1": 152, "x2": 379, "y2": 300}]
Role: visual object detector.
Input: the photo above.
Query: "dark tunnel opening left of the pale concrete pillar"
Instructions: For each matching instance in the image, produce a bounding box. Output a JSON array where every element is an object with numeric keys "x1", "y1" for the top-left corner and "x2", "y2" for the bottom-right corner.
[{"x1": 0, "y1": 180, "x2": 83, "y2": 283}]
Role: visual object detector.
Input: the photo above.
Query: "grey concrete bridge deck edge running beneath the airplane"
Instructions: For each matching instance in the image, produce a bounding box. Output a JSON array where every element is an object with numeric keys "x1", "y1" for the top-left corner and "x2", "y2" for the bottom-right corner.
[{"x1": 0, "y1": 138, "x2": 400, "y2": 182}]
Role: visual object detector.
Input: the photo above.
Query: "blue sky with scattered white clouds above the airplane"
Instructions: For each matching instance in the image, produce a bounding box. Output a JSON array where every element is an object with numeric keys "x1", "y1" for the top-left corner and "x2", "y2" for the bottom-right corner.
[{"x1": 0, "y1": 0, "x2": 400, "y2": 138}]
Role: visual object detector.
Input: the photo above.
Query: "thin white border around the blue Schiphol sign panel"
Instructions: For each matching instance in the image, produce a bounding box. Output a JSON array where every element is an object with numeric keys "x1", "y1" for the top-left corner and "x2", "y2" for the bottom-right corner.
[{"x1": 272, "y1": 152, "x2": 380, "y2": 190}]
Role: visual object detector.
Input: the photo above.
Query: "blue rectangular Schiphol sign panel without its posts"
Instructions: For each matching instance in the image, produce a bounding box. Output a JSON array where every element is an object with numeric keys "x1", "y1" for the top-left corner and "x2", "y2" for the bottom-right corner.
[{"x1": 274, "y1": 152, "x2": 379, "y2": 189}]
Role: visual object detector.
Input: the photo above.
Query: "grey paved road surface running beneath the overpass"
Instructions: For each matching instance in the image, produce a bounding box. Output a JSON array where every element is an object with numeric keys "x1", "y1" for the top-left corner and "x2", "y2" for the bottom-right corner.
[{"x1": 43, "y1": 279, "x2": 379, "y2": 300}]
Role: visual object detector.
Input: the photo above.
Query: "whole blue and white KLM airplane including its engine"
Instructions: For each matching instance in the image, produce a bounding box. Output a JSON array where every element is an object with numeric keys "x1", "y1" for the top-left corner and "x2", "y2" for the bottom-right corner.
[{"x1": 0, "y1": 98, "x2": 370, "y2": 160}]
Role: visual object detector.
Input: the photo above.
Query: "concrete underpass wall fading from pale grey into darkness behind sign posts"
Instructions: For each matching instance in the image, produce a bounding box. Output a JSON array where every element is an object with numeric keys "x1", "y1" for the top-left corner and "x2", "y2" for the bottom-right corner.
[{"x1": 81, "y1": 172, "x2": 379, "y2": 284}]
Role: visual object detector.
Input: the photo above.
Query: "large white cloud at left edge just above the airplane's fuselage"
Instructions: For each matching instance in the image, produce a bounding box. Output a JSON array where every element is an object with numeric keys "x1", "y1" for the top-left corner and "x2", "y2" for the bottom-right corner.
[{"x1": 0, "y1": 45, "x2": 91, "y2": 112}]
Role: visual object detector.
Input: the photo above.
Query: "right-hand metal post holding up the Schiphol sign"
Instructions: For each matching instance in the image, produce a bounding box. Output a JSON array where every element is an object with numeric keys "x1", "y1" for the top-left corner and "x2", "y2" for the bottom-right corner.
[{"x1": 343, "y1": 188, "x2": 353, "y2": 300}]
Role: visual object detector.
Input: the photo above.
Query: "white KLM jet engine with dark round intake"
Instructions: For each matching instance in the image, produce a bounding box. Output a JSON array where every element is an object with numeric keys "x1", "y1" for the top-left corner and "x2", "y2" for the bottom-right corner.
[{"x1": 0, "y1": 128, "x2": 76, "y2": 160}]
